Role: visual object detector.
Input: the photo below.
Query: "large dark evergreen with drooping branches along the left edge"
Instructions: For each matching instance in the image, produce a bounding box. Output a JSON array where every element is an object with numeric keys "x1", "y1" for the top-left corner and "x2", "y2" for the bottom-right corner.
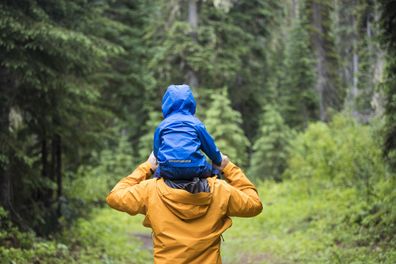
[{"x1": 0, "y1": 0, "x2": 120, "y2": 233}]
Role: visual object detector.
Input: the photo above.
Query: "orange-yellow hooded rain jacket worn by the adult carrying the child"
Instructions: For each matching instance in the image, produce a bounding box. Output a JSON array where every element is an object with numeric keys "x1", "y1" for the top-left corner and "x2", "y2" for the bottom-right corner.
[{"x1": 107, "y1": 162, "x2": 262, "y2": 264}]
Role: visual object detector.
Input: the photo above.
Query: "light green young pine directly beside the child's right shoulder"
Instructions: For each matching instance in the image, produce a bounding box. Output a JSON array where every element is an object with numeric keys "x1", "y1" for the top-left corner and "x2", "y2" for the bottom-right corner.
[{"x1": 204, "y1": 88, "x2": 249, "y2": 167}]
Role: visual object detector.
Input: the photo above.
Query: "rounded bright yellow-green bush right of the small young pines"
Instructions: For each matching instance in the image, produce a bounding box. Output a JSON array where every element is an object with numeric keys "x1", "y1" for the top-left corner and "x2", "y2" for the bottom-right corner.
[{"x1": 286, "y1": 115, "x2": 386, "y2": 200}]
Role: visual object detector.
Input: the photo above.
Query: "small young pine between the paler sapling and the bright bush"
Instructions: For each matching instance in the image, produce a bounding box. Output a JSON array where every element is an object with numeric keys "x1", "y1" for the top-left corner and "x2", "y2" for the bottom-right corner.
[{"x1": 248, "y1": 105, "x2": 292, "y2": 181}]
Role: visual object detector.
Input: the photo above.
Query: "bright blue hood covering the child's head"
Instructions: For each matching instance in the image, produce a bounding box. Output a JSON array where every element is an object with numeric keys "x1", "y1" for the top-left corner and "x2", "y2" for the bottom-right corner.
[{"x1": 162, "y1": 84, "x2": 196, "y2": 118}]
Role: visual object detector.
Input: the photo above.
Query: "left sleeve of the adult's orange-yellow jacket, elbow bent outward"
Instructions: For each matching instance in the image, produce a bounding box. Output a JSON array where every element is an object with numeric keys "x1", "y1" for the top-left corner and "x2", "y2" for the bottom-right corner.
[{"x1": 106, "y1": 162, "x2": 151, "y2": 215}]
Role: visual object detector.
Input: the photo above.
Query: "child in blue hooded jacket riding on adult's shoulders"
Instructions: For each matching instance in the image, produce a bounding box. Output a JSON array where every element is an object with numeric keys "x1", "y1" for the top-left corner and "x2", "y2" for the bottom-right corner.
[{"x1": 154, "y1": 84, "x2": 221, "y2": 180}]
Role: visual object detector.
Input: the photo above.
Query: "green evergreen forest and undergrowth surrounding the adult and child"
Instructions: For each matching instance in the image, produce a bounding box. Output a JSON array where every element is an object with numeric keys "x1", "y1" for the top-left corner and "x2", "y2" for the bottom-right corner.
[{"x1": 0, "y1": 0, "x2": 396, "y2": 264}]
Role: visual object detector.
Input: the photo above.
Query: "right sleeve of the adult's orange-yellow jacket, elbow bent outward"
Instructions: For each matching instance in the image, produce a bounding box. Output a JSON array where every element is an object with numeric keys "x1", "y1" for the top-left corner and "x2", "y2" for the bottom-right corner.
[{"x1": 223, "y1": 162, "x2": 263, "y2": 217}]
